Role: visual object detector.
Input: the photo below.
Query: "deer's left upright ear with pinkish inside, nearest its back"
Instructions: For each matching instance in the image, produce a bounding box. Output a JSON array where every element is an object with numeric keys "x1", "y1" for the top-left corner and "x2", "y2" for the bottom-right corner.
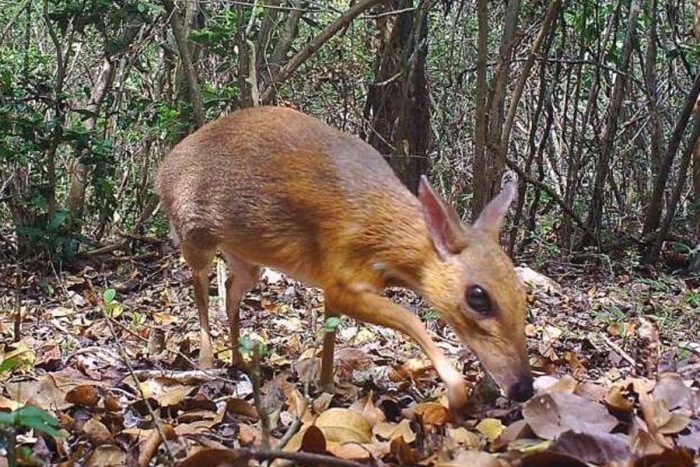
[{"x1": 418, "y1": 175, "x2": 467, "y2": 260}]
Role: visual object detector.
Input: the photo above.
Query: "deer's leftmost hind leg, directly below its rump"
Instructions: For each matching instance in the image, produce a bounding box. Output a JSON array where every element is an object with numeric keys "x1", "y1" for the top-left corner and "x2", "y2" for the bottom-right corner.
[{"x1": 181, "y1": 242, "x2": 216, "y2": 369}]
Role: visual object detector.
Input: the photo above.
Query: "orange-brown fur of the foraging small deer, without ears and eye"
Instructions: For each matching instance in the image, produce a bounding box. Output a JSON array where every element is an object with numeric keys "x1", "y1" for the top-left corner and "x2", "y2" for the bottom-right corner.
[{"x1": 156, "y1": 107, "x2": 529, "y2": 406}]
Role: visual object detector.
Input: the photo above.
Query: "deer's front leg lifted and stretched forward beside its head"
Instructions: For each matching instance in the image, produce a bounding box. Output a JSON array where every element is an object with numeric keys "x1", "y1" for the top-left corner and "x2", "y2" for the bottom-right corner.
[{"x1": 325, "y1": 285, "x2": 467, "y2": 412}]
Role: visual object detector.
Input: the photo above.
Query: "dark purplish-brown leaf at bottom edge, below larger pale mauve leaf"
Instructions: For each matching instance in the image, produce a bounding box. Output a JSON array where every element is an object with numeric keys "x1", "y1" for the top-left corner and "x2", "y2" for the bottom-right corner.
[{"x1": 549, "y1": 431, "x2": 632, "y2": 465}]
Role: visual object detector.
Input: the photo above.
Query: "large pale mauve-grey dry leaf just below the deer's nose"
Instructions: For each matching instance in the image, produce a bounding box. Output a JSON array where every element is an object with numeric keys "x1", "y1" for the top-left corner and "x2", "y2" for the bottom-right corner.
[{"x1": 523, "y1": 393, "x2": 618, "y2": 439}]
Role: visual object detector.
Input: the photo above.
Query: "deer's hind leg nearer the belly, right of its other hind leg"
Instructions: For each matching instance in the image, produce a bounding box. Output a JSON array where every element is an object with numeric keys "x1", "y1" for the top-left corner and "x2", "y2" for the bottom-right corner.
[{"x1": 224, "y1": 253, "x2": 260, "y2": 366}]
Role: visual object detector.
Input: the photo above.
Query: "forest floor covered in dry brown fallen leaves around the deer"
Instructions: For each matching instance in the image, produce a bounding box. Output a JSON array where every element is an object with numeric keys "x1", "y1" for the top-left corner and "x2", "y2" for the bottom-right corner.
[{"x1": 0, "y1": 232, "x2": 700, "y2": 466}]
